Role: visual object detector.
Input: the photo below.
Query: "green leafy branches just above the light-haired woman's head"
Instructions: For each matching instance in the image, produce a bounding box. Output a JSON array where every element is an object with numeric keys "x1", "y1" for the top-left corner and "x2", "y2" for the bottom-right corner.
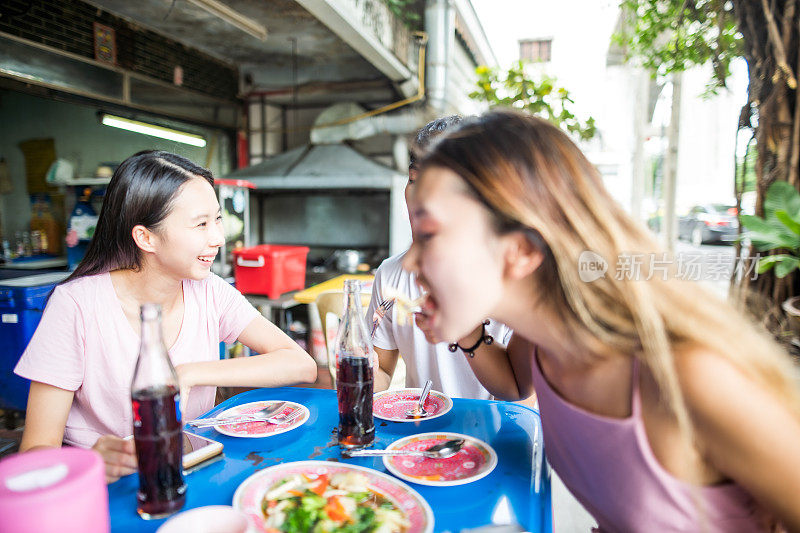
[{"x1": 469, "y1": 61, "x2": 597, "y2": 140}]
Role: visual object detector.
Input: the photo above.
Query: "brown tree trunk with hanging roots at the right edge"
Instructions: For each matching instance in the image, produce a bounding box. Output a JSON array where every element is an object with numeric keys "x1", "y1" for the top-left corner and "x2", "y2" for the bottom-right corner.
[{"x1": 733, "y1": 0, "x2": 800, "y2": 333}]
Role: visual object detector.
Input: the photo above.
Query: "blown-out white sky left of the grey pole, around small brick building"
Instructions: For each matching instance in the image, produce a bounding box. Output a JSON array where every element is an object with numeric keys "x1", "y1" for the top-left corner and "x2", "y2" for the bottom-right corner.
[{"x1": 472, "y1": 0, "x2": 636, "y2": 207}]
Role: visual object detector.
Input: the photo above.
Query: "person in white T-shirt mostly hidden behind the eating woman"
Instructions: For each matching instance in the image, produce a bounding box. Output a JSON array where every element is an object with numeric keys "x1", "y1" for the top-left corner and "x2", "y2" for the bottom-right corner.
[{"x1": 367, "y1": 115, "x2": 511, "y2": 400}]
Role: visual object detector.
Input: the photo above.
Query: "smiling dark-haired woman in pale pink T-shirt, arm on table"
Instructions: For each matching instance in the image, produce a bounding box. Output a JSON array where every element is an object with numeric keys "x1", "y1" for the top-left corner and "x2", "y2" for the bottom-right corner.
[{"x1": 15, "y1": 151, "x2": 316, "y2": 481}]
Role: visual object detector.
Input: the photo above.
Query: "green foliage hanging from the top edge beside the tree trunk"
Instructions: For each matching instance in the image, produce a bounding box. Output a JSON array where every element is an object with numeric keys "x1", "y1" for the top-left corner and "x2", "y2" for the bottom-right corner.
[{"x1": 613, "y1": 0, "x2": 743, "y2": 93}]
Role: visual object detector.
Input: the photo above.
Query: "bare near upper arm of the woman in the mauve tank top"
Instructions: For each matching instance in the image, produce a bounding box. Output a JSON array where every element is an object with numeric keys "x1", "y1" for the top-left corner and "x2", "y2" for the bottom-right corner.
[{"x1": 675, "y1": 348, "x2": 800, "y2": 530}]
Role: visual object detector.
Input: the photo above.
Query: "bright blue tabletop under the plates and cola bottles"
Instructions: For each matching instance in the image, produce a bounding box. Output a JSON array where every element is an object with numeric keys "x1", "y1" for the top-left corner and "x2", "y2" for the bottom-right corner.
[{"x1": 108, "y1": 387, "x2": 553, "y2": 533}]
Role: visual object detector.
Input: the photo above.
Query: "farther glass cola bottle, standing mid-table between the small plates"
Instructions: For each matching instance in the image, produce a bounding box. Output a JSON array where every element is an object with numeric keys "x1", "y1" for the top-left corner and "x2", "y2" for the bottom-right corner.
[{"x1": 334, "y1": 279, "x2": 375, "y2": 448}]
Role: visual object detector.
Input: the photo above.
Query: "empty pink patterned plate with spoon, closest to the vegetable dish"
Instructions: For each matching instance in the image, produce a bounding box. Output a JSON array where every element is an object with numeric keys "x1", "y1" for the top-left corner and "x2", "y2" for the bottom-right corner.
[{"x1": 383, "y1": 433, "x2": 497, "y2": 487}]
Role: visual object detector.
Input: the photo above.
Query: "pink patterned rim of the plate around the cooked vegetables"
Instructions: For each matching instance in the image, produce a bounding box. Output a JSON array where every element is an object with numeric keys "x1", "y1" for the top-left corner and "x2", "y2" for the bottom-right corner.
[{"x1": 233, "y1": 461, "x2": 433, "y2": 533}]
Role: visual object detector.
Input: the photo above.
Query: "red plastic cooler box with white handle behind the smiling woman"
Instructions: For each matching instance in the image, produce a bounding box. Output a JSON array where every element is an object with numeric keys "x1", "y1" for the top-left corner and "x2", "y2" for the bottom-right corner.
[{"x1": 233, "y1": 244, "x2": 308, "y2": 300}]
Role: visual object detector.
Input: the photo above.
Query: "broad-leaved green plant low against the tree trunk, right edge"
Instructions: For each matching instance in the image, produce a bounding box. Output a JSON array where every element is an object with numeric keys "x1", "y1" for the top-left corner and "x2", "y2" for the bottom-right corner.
[{"x1": 739, "y1": 181, "x2": 800, "y2": 278}]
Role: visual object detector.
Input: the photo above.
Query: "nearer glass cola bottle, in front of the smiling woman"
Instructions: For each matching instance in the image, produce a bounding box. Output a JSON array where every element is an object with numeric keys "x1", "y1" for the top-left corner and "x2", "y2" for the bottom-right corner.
[{"x1": 131, "y1": 304, "x2": 186, "y2": 520}]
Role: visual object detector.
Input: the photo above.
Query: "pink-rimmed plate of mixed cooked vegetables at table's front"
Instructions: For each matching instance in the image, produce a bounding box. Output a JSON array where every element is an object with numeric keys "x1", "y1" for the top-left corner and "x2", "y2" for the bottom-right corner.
[{"x1": 233, "y1": 461, "x2": 433, "y2": 533}]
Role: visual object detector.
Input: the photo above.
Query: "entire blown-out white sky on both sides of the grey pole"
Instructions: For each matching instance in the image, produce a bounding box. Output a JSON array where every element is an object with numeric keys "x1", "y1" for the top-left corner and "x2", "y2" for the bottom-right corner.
[{"x1": 472, "y1": 0, "x2": 747, "y2": 214}]
